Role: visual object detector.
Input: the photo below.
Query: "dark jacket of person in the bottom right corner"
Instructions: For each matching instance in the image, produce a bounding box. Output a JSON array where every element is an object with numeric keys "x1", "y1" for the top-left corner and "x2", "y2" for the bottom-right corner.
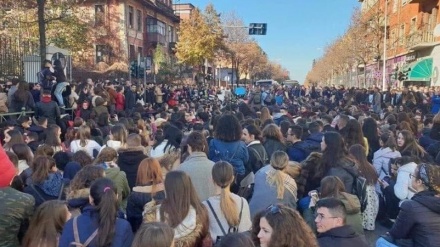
[{"x1": 390, "y1": 191, "x2": 440, "y2": 247}]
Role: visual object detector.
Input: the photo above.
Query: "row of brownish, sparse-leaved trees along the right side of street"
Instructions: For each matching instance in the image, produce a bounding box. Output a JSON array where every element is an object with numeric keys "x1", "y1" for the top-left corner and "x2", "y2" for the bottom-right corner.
[{"x1": 305, "y1": 4, "x2": 392, "y2": 86}]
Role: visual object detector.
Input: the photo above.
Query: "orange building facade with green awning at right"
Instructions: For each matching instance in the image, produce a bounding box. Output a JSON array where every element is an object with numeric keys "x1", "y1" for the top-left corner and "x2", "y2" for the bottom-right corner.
[{"x1": 361, "y1": 0, "x2": 440, "y2": 86}]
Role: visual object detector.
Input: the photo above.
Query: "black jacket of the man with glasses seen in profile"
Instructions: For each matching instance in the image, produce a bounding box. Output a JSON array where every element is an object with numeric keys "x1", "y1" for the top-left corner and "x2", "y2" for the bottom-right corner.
[{"x1": 318, "y1": 225, "x2": 369, "y2": 247}]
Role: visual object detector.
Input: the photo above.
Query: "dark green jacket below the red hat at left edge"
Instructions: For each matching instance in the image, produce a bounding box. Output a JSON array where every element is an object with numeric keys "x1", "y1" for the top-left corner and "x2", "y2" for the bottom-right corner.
[{"x1": 0, "y1": 187, "x2": 35, "y2": 247}]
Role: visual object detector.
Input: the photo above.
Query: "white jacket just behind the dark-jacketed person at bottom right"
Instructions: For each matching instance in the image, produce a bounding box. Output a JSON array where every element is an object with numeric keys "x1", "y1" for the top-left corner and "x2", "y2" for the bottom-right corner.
[{"x1": 394, "y1": 162, "x2": 417, "y2": 200}]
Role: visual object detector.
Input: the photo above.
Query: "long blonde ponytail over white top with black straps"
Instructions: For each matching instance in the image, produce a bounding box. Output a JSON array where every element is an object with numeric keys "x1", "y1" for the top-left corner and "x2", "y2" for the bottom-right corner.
[{"x1": 212, "y1": 161, "x2": 240, "y2": 226}]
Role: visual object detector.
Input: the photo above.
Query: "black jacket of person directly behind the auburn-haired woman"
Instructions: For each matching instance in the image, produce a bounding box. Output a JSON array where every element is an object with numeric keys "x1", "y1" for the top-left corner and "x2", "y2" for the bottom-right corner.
[{"x1": 117, "y1": 147, "x2": 147, "y2": 189}]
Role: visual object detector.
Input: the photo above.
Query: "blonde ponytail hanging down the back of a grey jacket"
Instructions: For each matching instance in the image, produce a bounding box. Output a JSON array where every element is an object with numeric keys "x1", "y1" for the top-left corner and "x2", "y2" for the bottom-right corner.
[{"x1": 267, "y1": 151, "x2": 289, "y2": 199}]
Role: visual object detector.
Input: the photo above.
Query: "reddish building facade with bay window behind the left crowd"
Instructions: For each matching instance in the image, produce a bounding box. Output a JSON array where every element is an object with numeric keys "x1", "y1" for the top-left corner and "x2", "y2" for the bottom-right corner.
[{"x1": 81, "y1": 0, "x2": 180, "y2": 69}]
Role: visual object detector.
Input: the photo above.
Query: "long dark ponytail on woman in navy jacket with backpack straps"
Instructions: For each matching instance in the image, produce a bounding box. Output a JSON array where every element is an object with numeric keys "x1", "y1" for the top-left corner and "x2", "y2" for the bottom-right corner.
[{"x1": 90, "y1": 178, "x2": 118, "y2": 246}]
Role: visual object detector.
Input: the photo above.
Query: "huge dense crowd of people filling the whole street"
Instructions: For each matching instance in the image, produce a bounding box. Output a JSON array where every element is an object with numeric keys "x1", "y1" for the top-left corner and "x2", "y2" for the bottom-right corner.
[{"x1": 0, "y1": 66, "x2": 440, "y2": 247}]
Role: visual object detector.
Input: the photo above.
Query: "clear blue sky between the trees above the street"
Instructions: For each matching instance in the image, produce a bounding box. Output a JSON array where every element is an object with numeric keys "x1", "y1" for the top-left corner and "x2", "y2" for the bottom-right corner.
[{"x1": 179, "y1": 0, "x2": 360, "y2": 83}]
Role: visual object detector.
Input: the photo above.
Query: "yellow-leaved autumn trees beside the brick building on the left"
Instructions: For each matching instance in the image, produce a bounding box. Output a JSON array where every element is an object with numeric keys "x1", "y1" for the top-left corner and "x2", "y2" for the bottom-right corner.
[{"x1": 176, "y1": 4, "x2": 289, "y2": 83}]
